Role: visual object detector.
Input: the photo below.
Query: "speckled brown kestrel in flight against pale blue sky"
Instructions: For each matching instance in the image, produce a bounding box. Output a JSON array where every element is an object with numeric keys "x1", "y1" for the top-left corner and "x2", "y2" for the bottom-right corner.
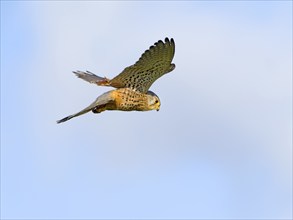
[{"x1": 57, "y1": 38, "x2": 175, "y2": 123}]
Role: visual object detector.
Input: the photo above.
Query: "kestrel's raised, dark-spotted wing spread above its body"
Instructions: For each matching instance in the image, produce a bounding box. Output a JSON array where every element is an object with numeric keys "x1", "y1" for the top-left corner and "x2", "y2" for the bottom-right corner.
[{"x1": 109, "y1": 38, "x2": 175, "y2": 93}]
